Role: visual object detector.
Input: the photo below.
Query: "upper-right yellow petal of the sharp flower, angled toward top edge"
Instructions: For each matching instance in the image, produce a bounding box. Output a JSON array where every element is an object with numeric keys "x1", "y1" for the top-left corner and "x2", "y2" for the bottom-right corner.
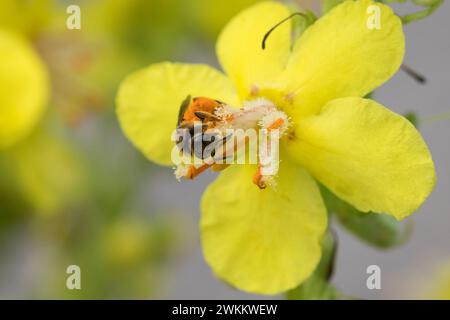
[{"x1": 282, "y1": 0, "x2": 404, "y2": 116}]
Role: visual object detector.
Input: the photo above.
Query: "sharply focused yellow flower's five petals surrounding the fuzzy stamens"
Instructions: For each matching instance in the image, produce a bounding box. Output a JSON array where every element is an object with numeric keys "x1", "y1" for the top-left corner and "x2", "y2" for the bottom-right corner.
[{"x1": 117, "y1": 0, "x2": 435, "y2": 294}]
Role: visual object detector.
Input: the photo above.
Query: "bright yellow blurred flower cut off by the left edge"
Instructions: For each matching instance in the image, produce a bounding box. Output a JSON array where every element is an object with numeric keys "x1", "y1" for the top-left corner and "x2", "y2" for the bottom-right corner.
[{"x1": 0, "y1": 30, "x2": 49, "y2": 149}]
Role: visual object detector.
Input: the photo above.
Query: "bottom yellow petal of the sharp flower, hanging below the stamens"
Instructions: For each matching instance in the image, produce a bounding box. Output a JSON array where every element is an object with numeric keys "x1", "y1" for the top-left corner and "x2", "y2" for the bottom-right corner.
[{"x1": 201, "y1": 159, "x2": 327, "y2": 294}]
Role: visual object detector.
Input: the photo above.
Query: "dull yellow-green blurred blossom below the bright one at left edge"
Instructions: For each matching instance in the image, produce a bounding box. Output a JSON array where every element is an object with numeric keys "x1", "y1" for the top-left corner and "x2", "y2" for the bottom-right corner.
[{"x1": 4, "y1": 130, "x2": 85, "y2": 215}]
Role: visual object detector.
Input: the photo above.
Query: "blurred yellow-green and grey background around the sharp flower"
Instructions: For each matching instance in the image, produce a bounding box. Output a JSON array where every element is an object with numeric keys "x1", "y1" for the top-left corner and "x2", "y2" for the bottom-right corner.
[{"x1": 0, "y1": 0, "x2": 450, "y2": 299}]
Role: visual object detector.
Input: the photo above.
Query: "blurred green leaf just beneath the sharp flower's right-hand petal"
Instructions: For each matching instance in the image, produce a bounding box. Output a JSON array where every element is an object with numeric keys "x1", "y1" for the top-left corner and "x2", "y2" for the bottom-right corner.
[{"x1": 322, "y1": 187, "x2": 412, "y2": 249}]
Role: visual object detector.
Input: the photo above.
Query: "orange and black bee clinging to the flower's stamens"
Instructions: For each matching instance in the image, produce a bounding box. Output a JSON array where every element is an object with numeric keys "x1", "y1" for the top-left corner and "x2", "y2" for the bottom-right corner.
[{"x1": 177, "y1": 96, "x2": 225, "y2": 160}]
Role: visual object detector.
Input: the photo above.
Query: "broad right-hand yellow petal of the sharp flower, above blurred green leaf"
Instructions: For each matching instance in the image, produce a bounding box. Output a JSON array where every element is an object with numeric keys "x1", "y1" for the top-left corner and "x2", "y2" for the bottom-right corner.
[{"x1": 287, "y1": 98, "x2": 435, "y2": 220}]
